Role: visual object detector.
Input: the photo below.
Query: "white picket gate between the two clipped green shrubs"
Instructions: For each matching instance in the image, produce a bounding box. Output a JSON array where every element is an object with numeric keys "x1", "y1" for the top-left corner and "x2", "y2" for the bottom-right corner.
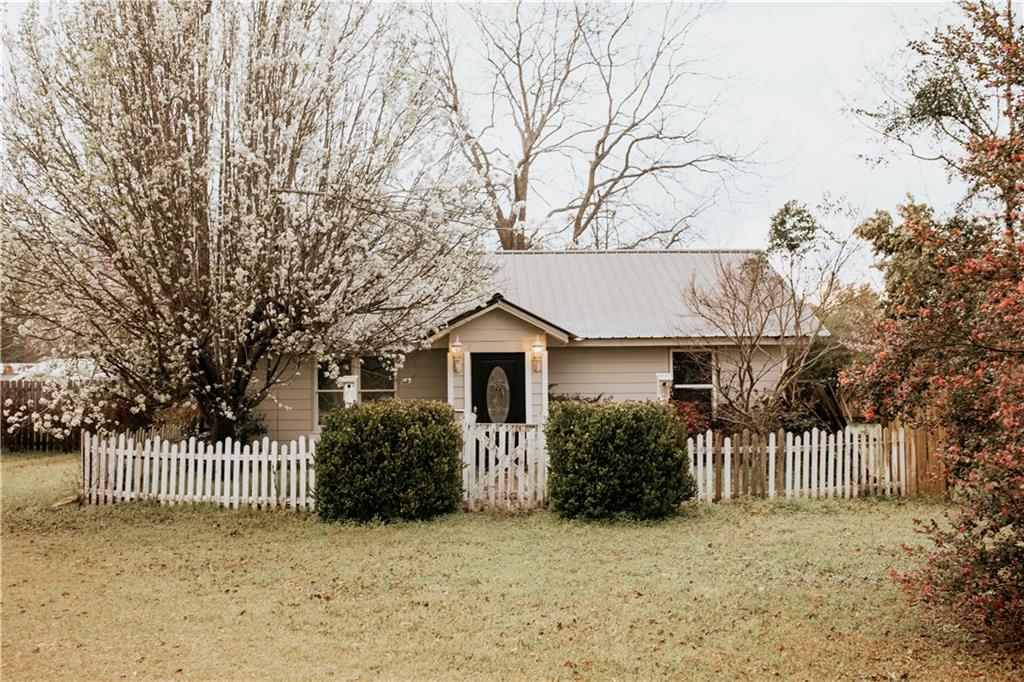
[{"x1": 462, "y1": 422, "x2": 548, "y2": 510}]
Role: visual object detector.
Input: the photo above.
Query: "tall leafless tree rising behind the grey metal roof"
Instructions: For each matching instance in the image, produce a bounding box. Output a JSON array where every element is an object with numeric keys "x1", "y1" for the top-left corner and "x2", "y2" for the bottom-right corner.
[{"x1": 428, "y1": 2, "x2": 740, "y2": 249}]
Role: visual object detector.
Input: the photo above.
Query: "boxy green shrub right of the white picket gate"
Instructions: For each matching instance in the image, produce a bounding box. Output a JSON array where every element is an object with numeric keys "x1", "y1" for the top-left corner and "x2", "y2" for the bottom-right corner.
[{"x1": 545, "y1": 401, "x2": 696, "y2": 519}]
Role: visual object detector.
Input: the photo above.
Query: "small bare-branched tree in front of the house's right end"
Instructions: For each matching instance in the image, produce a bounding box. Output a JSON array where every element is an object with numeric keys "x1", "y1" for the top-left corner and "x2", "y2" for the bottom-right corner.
[{"x1": 683, "y1": 202, "x2": 853, "y2": 432}]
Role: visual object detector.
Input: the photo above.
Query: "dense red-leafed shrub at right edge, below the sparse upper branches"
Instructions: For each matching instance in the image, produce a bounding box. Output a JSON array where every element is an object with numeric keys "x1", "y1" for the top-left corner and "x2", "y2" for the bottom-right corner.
[{"x1": 844, "y1": 206, "x2": 1024, "y2": 641}]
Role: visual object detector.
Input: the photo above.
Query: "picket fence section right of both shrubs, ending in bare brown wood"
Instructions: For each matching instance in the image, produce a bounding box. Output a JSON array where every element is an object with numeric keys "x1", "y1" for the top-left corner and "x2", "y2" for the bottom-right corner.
[{"x1": 687, "y1": 426, "x2": 945, "y2": 502}]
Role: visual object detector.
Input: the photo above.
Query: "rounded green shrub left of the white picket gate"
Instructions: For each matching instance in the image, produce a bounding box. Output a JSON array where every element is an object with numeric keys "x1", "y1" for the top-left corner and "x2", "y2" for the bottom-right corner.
[{"x1": 315, "y1": 400, "x2": 462, "y2": 521}]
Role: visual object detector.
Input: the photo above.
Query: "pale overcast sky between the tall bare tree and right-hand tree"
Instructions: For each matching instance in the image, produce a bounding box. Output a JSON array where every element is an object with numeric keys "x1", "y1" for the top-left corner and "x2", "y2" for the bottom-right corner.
[{"x1": 4, "y1": 2, "x2": 962, "y2": 273}]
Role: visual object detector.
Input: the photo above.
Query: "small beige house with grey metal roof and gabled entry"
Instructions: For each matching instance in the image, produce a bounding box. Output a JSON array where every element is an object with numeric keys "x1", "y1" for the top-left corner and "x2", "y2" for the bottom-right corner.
[{"x1": 258, "y1": 250, "x2": 782, "y2": 439}]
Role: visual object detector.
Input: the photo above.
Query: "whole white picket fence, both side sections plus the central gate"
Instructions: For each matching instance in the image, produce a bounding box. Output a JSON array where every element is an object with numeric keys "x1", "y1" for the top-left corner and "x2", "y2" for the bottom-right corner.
[{"x1": 82, "y1": 423, "x2": 945, "y2": 510}]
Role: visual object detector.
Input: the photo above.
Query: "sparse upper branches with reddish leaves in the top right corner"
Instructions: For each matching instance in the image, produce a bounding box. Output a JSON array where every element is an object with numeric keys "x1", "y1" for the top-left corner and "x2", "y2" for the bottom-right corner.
[{"x1": 860, "y1": 0, "x2": 1024, "y2": 227}]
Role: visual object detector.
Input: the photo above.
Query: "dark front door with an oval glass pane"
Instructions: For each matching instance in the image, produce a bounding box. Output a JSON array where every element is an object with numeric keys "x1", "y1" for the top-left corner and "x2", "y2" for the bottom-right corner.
[{"x1": 470, "y1": 353, "x2": 526, "y2": 424}]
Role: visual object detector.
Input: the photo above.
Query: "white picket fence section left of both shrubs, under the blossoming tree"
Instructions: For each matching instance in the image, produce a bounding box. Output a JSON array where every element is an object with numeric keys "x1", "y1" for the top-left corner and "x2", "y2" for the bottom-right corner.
[{"x1": 82, "y1": 433, "x2": 316, "y2": 509}]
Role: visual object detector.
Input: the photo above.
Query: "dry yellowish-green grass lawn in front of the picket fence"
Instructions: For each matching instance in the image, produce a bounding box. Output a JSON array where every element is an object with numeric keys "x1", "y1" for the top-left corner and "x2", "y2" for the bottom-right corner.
[{"x1": 0, "y1": 448, "x2": 1024, "y2": 680}]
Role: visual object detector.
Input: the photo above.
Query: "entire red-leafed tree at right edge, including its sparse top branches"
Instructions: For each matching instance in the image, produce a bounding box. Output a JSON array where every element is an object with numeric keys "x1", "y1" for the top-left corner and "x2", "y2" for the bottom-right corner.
[{"x1": 845, "y1": 1, "x2": 1024, "y2": 641}]
